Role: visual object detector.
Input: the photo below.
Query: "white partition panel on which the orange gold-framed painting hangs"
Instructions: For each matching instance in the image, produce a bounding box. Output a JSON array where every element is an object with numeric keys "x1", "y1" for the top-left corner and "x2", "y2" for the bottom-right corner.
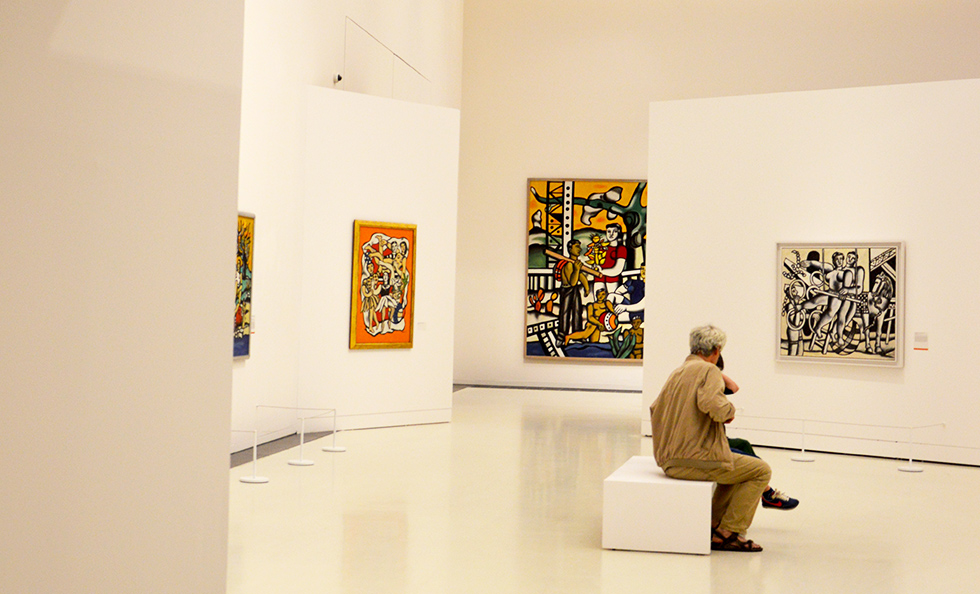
[{"x1": 299, "y1": 87, "x2": 459, "y2": 429}]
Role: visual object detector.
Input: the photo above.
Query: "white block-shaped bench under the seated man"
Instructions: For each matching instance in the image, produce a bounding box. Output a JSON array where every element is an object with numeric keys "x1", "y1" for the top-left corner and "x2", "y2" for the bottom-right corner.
[{"x1": 602, "y1": 456, "x2": 714, "y2": 555}]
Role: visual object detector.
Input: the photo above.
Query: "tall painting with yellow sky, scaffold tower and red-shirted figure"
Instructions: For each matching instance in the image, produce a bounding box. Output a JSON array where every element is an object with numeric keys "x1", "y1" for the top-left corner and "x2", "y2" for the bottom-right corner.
[{"x1": 524, "y1": 179, "x2": 647, "y2": 361}]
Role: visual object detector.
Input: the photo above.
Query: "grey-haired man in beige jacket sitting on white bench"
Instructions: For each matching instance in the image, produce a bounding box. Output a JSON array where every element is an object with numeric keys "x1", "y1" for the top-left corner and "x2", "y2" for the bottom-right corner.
[{"x1": 650, "y1": 325, "x2": 772, "y2": 553}]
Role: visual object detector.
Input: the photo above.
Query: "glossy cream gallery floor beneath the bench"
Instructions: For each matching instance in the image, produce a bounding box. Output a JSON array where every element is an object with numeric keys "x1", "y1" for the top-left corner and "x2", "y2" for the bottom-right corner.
[{"x1": 228, "y1": 388, "x2": 980, "y2": 594}]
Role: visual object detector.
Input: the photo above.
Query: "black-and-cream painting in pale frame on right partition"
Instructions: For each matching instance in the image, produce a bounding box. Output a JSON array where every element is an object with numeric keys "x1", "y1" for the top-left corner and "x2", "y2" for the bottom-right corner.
[{"x1": 776, "y1": 242, "x2": 905, "y2": 367}]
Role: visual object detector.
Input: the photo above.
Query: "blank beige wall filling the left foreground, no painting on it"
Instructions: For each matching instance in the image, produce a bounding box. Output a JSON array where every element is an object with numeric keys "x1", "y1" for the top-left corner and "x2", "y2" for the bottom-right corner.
[{"x1": 0, "y1": 0, "x2": 243, "y2": 594}]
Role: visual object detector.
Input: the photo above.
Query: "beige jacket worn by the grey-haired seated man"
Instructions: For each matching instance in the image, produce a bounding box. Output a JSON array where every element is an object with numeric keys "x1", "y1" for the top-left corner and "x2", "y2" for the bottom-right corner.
[{"x1": 650, "y1": 355, "x2": 735, "y2": 470}]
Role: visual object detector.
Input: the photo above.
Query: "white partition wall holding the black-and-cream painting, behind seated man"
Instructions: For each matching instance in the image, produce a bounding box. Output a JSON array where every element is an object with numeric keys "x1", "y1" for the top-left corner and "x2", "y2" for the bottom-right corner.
[{"x1": 644, "y1": 80, "x2": 980, "y2": 464}]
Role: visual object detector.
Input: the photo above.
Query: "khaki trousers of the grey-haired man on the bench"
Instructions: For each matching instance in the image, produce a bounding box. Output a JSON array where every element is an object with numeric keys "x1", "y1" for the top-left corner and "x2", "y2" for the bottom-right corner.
[{"x1": 664, "y1": 454, "x2": 772, "y2": 535}]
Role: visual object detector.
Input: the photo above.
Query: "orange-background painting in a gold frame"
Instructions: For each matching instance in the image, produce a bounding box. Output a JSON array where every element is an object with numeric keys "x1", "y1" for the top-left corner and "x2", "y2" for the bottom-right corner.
[{"x1": 350, "y1": 221, "x2": 416, "y2": 349}]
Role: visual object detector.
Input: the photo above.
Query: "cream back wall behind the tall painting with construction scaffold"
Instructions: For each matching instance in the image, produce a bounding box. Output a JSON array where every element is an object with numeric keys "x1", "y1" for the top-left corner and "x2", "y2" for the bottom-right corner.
[{"x1": 455, "y1": 0, "x2": 980, "y2": 389}]
